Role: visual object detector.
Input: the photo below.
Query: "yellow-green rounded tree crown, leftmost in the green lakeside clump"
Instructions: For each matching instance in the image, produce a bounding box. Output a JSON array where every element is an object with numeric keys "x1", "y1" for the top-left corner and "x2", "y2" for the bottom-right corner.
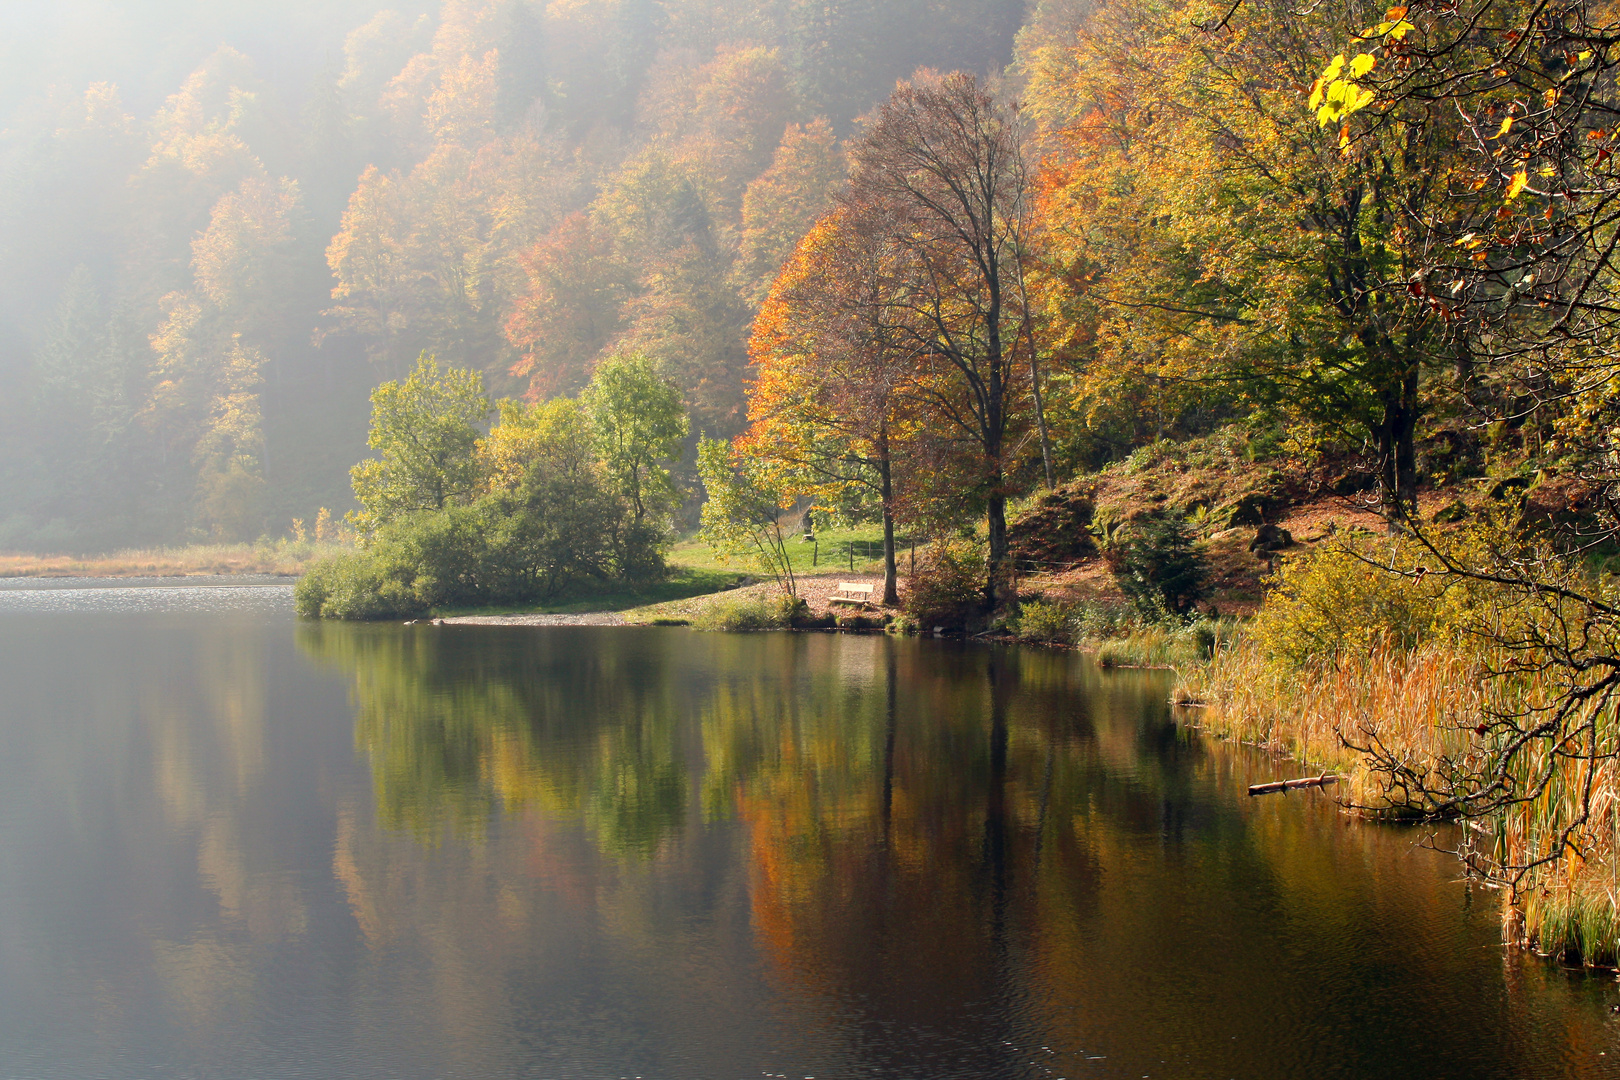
[{"x1": 348, "y1": 353, "x2": 489, "y2": 534}]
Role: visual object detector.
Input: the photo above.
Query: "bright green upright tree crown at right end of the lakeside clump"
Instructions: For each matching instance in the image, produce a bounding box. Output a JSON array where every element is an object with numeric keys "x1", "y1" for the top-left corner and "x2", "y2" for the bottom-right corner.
[{"x1": 580, "y1": 353, "x2": 687, "y2": 523}]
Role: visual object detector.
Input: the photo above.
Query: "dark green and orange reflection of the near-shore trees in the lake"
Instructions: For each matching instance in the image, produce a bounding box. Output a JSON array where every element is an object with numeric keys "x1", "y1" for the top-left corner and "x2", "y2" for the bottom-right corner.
[{"x1": 301, "y1": 627, "x2": 1620, "y2": 1077}]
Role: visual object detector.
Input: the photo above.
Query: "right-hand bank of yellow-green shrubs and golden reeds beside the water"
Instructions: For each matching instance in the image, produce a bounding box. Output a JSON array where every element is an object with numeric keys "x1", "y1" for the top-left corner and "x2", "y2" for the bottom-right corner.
[{"x1": 1176, "y1": 547, "x2": 1620, "y2": 967}]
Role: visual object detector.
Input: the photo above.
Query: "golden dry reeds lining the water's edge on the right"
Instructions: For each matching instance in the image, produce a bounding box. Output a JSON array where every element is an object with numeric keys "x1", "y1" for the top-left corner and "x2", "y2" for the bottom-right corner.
[{"x1": 1176, "y1": 638, "x2": 1620, "y2": 967}]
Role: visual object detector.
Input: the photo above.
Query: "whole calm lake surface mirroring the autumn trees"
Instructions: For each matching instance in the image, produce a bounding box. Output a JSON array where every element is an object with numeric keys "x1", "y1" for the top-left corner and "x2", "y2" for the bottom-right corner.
[{"x1": 0, "y1": 583, "x2": 1620, "y2": 1080}]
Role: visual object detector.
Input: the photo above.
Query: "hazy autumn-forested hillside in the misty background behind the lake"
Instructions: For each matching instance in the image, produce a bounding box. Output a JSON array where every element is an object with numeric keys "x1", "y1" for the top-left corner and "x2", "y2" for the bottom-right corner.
[{"x1": 0, "y1": 0, "x2": 1024, "y2": 551}]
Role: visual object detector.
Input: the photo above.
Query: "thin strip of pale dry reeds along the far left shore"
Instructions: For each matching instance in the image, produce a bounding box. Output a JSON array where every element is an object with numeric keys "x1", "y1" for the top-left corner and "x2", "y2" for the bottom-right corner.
[{"x1": 0, "y1": 539, "x2": 345, "y2": 578}]
